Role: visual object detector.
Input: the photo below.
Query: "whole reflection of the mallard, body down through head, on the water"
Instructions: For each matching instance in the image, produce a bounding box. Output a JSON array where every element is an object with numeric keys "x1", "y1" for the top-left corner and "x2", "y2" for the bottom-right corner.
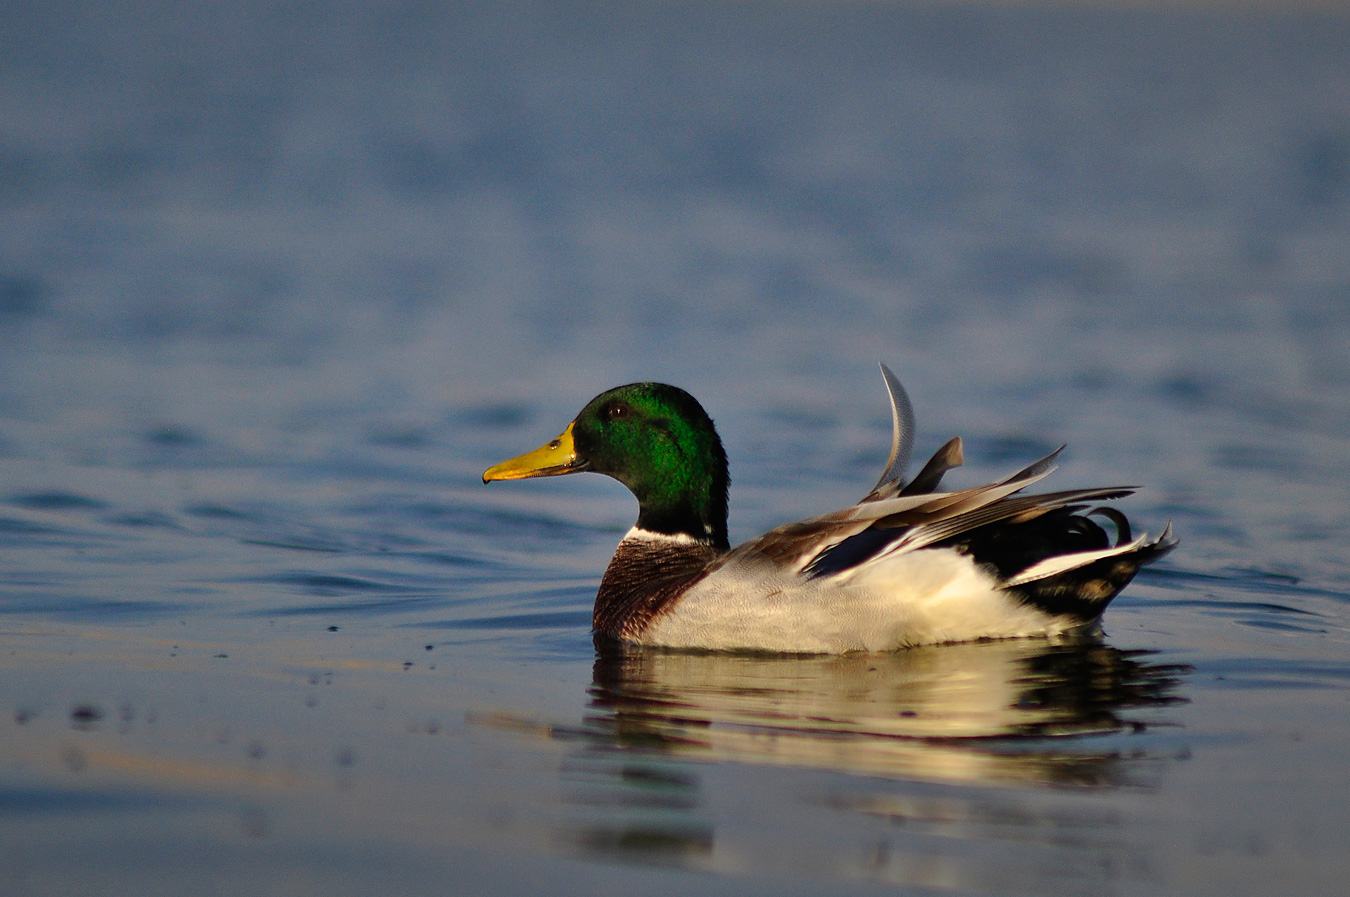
[{"x1": 507, "y1": 639, "x2": 1185, "y2": 893}]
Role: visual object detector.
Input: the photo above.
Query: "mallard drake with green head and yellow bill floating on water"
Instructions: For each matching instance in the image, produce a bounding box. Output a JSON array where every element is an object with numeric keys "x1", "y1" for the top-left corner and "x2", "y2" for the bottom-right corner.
[{"x1": 483, "y1": 365, "x2": 1179, "y2": 654}]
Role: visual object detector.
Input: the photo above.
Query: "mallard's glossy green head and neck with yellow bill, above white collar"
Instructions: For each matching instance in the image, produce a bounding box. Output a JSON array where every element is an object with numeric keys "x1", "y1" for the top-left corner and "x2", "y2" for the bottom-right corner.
[{"x1": 483, "y1": 384, "x2": 730, "y2": 551}]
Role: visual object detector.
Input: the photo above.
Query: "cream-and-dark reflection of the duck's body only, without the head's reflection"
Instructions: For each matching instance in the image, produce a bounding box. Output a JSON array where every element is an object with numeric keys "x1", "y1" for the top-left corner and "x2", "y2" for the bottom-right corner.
[{"x1": 586, "y1": 639, "x2": 1185, "y2": 785}]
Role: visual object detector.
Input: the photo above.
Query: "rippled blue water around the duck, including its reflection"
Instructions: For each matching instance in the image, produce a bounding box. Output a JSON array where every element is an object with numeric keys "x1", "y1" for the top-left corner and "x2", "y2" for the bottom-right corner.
[{"x1": 0, "y1": 3, "x2": 1350, "y2": 896}]
